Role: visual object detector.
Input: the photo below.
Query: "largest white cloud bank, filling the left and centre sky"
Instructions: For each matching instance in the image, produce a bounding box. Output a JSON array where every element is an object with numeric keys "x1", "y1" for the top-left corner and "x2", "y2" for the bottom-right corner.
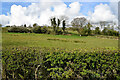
[{"x1": 0, "y1": 0, "x2": 81, "y2": 25}]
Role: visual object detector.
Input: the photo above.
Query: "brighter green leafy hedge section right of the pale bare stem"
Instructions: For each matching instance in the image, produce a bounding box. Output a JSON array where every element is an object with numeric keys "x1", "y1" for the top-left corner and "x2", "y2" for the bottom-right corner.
[{"x1": 44, "y1": 51, "x2": 120, "y2": 80}]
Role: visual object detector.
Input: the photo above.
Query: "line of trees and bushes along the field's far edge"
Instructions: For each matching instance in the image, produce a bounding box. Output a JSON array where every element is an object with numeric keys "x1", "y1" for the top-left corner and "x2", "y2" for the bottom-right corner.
[{"x1": 2, "y1": 16, "x2": 119, "y2": 36}]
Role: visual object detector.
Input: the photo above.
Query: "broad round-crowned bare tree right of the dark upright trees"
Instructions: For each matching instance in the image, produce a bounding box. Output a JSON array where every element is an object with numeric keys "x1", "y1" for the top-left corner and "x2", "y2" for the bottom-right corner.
[{"x1": 71, "y1": 17, "x2": 87, "y2": 35}]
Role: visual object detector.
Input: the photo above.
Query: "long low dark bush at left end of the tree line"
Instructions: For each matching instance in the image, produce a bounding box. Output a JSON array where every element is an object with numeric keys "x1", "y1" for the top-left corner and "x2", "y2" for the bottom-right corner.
[{"x1": 8, "y1": 27, "x2": 31, "y2": 33}]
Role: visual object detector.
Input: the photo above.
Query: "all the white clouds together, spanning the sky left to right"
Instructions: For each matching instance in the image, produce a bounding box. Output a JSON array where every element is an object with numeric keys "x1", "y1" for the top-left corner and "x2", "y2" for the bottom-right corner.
[{"x1": 0, "y1": 0, "x2": 117, "y2": 25}]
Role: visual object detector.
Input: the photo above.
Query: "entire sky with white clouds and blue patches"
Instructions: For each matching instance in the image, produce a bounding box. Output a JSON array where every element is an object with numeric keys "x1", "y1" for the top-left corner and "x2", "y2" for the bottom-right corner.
[{"x1": 0, "y1": 0, "x2": 118, "y2": 25}]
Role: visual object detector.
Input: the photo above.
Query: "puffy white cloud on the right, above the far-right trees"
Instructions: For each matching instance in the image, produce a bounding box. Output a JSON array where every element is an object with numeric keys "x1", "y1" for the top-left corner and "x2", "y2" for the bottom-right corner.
[{"x1": 89, "y1": 4, "x2": 116, "y2": 22}]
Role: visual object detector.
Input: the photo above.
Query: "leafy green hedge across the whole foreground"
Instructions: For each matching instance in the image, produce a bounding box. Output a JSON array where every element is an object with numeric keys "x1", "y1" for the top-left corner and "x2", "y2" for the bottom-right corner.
[{"x1": 2, "y1": 48, "x2": 120, "y2": 80}]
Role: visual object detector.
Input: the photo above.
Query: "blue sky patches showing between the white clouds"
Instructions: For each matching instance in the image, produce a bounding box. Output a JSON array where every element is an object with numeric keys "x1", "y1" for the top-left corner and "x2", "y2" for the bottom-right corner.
[{"x1": 2, "y1": 2, "x2": 109, "y2": 16}]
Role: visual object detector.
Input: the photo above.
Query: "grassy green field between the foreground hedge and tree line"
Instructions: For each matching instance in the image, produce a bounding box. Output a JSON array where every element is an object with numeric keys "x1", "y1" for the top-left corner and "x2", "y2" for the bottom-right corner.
[{"x1": 2, "y1": 33, "x2": 118, "y2": 49}]
